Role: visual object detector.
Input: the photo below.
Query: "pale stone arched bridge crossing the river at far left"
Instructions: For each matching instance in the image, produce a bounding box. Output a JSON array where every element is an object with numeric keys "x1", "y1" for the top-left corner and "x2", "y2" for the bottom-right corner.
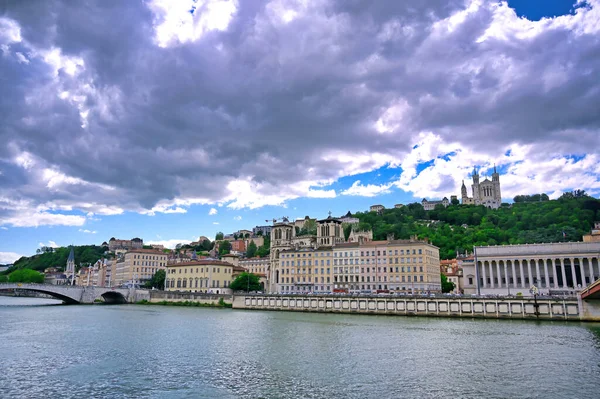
[{"x1": 0, "y1": 283, "x2": 136, "y2": 304}]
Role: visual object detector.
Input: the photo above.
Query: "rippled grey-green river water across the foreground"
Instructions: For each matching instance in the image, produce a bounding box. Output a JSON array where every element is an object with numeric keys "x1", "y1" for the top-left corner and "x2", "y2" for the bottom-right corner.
[{"x1": 0, "y1": 297, "x2": 600, "y2": 399}]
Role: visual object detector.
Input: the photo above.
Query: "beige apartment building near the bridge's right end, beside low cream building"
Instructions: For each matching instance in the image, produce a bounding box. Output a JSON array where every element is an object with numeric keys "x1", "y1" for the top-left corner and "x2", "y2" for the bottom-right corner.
[{"x1": 112, "y1": 249, "x2": 167, "y2": 287}]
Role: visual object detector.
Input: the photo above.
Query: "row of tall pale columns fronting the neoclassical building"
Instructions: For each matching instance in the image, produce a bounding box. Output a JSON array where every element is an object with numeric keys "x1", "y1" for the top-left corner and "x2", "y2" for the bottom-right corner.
[{"x1": 477, "y1": 256, "x2": 600, "y2": 290}]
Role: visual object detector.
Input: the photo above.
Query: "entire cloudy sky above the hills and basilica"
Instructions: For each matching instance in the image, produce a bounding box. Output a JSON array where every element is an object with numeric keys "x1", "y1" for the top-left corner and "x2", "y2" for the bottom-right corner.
[{"x1": 0, "y1": 0, "x2": 600, "y2": 263}]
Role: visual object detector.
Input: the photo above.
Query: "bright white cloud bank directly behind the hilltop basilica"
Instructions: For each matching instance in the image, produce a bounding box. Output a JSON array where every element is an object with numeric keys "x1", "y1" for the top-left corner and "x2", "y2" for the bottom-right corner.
[{"x1": 394, "y1": 134, "x2": 600, "y2": 201}]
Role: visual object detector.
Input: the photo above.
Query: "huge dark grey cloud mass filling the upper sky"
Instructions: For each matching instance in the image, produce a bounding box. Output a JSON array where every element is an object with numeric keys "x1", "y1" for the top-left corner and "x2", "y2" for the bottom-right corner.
[{"x1": 0, "y1": 0, "x2": 600, "y2": 223}]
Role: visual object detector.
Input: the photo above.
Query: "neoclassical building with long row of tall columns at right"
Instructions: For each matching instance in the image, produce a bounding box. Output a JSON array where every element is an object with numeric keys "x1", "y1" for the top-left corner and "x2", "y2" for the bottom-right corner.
[{"x1": 463, "y1": 242, "x2": 600, "y2": 296}]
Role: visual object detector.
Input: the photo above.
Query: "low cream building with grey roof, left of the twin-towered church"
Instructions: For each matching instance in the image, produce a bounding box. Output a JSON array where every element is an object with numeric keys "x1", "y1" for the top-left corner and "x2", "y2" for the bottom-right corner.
[{"x1": 165, "y1": 259, "x2": 236, "y2": 294}]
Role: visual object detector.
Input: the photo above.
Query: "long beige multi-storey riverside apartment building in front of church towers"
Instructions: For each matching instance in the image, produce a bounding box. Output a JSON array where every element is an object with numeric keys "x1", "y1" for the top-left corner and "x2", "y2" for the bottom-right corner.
[{"x1": 276, "y1": 239, "x2": 441, "y2": 293}]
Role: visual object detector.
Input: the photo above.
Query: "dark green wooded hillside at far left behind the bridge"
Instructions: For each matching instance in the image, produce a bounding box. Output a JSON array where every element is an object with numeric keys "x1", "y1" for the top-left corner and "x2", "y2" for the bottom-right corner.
[{"x1": 4, "y1": 245, "x2": 108, "y2": 273}]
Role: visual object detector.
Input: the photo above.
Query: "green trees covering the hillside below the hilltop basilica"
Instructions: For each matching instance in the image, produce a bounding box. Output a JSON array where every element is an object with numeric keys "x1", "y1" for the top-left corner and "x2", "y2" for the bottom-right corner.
[{"x1": 355, "y1": 193, "x2": 600, "y2": 259}]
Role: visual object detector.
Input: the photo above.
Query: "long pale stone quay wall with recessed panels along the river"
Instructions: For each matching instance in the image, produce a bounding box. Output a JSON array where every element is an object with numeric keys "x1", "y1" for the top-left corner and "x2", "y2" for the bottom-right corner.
[{"x1": 233, "y1": 295, "x2": 600, "y2": 321}]
